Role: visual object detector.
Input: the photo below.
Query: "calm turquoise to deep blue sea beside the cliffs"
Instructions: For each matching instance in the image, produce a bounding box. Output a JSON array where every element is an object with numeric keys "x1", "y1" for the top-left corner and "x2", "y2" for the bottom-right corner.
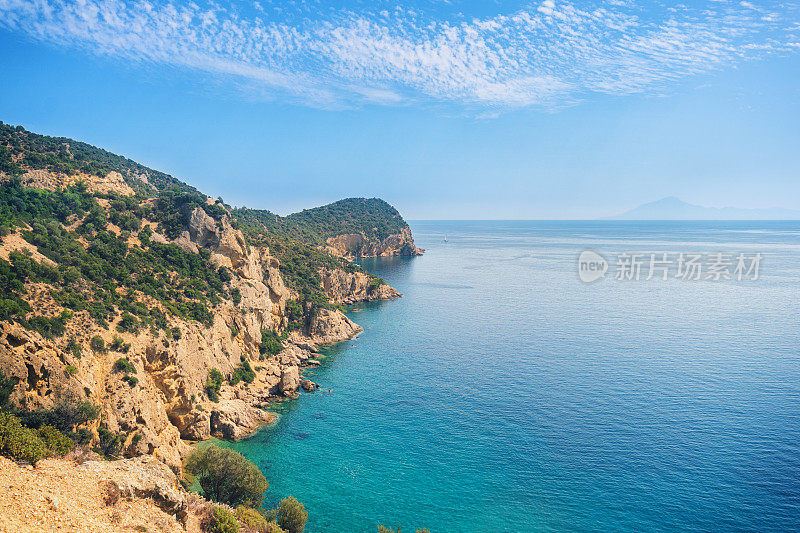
[{"x1": 228, "y1": 222, "x2": 800, "y2": 533}]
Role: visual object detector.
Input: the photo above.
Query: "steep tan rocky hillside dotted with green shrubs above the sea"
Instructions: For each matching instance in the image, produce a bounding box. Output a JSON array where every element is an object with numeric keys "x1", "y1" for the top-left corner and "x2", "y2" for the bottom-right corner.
[{"x1": 0, "y1": 124, "x2": 410, "y2": 482}]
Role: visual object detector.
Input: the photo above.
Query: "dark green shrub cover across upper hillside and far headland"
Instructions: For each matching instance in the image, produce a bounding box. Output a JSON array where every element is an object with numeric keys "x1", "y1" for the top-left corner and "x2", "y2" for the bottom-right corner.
[{"x1": 0, "y1": 122, "x2": 392, "y2": 337}]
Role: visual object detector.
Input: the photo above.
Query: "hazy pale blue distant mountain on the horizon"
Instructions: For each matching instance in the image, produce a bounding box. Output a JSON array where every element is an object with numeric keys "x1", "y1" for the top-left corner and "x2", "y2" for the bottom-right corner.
[{"x1": 608, "y1": 196, "x2": 800, "y2": 220}]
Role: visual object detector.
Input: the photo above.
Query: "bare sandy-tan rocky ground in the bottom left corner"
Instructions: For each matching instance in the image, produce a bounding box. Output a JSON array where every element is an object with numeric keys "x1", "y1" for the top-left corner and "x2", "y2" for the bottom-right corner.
[{"x1": 0, "y1": 456, "x2": 193, "y2": 533}]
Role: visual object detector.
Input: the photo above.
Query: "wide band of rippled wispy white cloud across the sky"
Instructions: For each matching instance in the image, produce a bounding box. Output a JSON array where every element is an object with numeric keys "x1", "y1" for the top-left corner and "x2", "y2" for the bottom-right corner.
[{"x1": 0, "y1": 0, "x2": 798, "y2": 110}]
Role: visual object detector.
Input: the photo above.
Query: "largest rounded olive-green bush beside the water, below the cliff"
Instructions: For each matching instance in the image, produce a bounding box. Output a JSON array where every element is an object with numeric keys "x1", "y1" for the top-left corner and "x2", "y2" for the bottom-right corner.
[{"x1": 184, "y1": 445, "x2": 269, "y2": 507}]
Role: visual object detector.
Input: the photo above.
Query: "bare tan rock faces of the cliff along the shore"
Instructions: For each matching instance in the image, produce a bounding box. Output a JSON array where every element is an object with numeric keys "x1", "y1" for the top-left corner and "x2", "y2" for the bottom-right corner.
[{"x1": 0, "y1": 171, "x2": 400, "y2": 472}]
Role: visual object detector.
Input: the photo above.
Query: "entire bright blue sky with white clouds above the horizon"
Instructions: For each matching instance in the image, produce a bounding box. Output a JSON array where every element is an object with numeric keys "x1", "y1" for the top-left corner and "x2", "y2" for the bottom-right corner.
[{"x1": 0, "y1": 0, "x2": 800, "y2": 220}]
